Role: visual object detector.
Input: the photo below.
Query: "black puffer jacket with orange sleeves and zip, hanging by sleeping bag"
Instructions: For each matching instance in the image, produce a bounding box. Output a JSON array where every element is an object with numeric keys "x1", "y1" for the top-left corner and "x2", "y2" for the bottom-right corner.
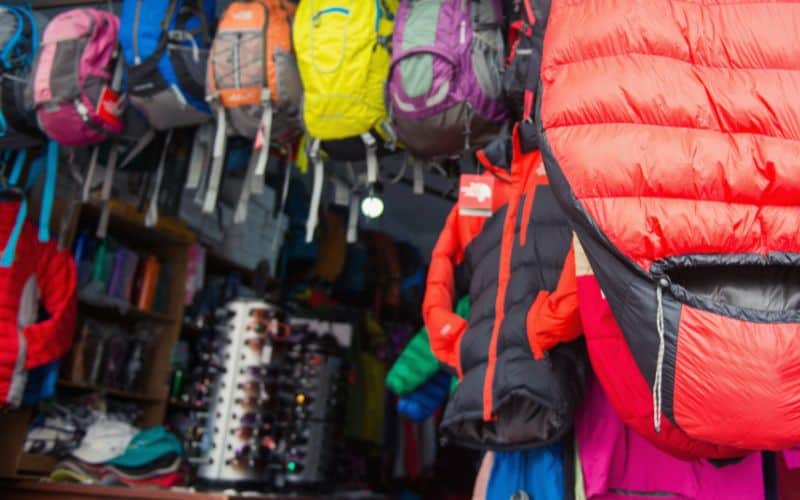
[{"x1": 423, "y1": 126, "x2": 584, "y2": 449}]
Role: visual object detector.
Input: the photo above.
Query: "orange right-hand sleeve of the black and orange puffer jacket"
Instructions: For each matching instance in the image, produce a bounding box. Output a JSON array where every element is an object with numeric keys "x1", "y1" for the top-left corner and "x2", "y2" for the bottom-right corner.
[{"x1": 527, "y1": 245, "x2": 583, "y2": 359}]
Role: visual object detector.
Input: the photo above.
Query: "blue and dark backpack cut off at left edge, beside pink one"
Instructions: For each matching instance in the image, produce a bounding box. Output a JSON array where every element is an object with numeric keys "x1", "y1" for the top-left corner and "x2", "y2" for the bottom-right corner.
[{"x1": 0, "y1": 5, "x2": 46, "y2": 149}]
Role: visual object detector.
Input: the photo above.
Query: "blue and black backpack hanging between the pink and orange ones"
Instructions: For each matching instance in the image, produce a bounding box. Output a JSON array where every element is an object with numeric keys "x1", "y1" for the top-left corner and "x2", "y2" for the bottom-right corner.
[{"x1": 119, "y1": 0, "x2": 215, "y2": 130}]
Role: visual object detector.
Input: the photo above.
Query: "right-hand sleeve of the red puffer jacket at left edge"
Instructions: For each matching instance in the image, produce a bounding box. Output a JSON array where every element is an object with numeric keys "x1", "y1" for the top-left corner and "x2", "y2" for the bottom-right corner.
[{"x1": 23, "y1": 242, "x2": 78, "y2": 369}]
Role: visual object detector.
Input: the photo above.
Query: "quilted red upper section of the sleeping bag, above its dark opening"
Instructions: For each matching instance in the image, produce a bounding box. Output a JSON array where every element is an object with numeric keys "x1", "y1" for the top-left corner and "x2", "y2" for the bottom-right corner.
[{"x1": 542, "y1": 0, "x2": 800, "y2": 269}]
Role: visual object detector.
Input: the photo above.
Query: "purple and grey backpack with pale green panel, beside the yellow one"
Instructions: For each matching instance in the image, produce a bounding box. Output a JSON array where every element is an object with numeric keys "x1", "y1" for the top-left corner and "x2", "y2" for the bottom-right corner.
[{"x1": 388, "y1": 0, "x2": 509, "y2": 157}]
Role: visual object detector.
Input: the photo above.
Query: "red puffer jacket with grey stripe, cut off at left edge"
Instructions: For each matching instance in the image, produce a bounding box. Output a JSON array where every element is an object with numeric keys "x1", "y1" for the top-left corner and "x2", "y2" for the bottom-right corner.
[{"x1": 0, "y1": 202, "x2": 77, "y2": 407}]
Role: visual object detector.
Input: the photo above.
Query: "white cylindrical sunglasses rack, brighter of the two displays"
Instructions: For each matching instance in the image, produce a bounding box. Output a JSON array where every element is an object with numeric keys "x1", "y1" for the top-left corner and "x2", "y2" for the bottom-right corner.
[{"x1": 197, "y1": 300, "x2": 281, "y2": 489}]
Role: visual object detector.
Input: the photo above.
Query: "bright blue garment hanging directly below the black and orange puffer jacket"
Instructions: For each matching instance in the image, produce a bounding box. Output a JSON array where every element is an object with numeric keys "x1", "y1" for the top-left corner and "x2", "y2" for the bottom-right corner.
[{"x1": 486, "y1": 442, "x2": 564, "y2": 500}]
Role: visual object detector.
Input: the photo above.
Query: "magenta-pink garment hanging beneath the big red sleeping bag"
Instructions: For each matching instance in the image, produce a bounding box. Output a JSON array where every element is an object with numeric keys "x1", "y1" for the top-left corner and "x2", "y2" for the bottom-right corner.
[{"x1": 575, "y1": 378, "x2": 764, "y2": 500}]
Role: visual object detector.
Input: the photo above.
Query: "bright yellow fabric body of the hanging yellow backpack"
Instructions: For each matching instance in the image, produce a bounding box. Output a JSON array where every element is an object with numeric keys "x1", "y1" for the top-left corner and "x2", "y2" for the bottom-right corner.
[{"x1": 292, "y1": 0, "x2": 397, "y2": 141}]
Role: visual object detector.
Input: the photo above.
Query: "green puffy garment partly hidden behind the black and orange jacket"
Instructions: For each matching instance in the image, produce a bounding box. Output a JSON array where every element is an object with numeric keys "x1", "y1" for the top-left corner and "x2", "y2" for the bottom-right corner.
[{"x1": 386, "y1": 297, "x2": 469, "y2": 396}]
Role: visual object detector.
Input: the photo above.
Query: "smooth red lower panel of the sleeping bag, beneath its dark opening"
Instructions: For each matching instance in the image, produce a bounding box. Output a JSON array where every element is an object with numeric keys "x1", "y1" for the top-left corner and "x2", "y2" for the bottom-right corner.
[{"x1": 674, "y1": 306, "x2": 800, "y2": 450}]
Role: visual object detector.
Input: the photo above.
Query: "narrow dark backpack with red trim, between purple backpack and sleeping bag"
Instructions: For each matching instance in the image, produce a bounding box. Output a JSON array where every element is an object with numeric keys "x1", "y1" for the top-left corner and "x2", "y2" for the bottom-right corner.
[{"x1": 503, "y1": 0, "x2": 550, "y2": 127}]
